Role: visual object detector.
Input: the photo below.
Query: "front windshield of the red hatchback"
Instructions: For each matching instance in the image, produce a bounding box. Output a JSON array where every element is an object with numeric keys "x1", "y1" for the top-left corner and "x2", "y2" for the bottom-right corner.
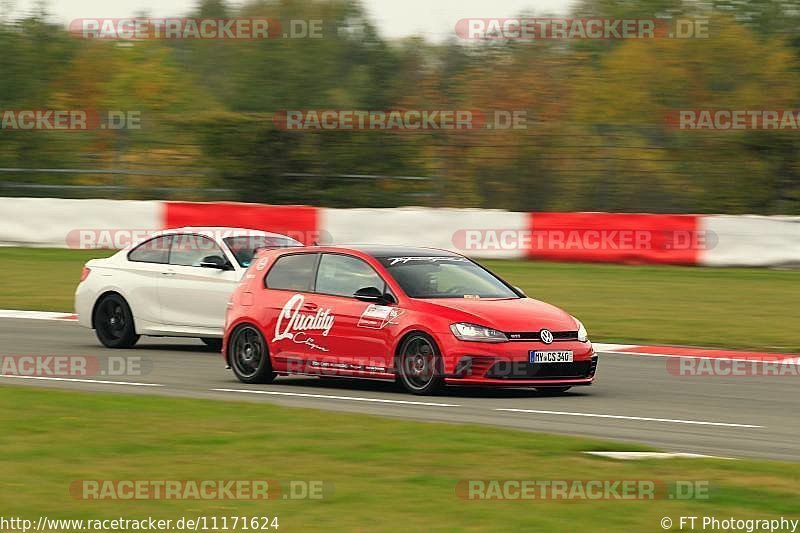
[{"x1": 378, "y1": 256, "x2": 519, "y2": 298}]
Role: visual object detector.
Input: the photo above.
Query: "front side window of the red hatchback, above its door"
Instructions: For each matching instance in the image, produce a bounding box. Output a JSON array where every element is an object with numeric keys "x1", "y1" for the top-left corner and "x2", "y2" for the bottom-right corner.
[{"x1": 316, "y1": 254, "x2": 384, "y2": 297}]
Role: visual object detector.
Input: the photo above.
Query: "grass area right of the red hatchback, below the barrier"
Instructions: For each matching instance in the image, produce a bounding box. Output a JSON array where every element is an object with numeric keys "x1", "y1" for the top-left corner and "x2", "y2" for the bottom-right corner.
[{"x1": 485, "y1": 261, "x2": 800, "y2": 352}]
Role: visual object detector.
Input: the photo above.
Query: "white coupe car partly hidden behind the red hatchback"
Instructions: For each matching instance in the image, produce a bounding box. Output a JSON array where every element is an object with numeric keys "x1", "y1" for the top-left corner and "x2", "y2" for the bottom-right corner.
[{"x1": 75, "y1": 228, "x2": 303, "y2": 349}]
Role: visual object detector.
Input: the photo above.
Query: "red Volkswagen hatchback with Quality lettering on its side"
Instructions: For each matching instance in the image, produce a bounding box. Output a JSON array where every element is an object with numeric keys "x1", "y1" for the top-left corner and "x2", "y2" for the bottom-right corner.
[{"x1": 223, "y1": 246, "x2": 597, "y2": 394}]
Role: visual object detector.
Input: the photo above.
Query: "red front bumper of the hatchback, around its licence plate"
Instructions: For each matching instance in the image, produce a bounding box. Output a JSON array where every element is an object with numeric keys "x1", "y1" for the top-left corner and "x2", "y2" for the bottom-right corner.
[{"x1": 442, "y1": 339, "x2": 598, "y2": 387}]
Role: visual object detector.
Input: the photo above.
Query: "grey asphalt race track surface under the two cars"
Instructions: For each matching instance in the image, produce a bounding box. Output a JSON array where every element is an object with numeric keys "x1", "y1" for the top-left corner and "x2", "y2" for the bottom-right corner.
[{"x1": 0, "y1": 319, "x2": 800, "y2": 461}]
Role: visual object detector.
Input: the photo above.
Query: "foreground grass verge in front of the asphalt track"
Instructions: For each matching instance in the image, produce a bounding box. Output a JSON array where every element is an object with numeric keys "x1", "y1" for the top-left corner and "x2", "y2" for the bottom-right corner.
[{"x1": 0, "y1": 387, "x2": 800, "y2": 531}]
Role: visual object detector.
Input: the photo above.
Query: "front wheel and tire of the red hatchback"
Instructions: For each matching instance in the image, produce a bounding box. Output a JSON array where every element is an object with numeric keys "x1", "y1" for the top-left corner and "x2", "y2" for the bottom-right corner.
[{"x1": 397, "y1": 333, "x2": 444, "y2": 395}]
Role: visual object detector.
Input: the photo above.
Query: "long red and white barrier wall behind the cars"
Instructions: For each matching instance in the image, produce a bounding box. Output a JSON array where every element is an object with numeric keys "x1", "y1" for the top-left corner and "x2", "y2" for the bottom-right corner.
[{"x1": 0, "y1": 198, "x2": 800, "y2": 267}]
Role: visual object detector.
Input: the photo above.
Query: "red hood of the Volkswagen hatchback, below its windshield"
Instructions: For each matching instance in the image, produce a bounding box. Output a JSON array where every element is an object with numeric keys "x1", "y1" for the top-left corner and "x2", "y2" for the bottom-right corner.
[{"x1": 416, "y1": 298, "x2": 578, "y2": 332}]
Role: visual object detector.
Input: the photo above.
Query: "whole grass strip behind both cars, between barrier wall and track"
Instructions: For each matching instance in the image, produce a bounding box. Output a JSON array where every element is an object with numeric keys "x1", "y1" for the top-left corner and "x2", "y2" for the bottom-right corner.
[{"x1": 0, "y1": 248, "x2": 800, "y2": 352}]
